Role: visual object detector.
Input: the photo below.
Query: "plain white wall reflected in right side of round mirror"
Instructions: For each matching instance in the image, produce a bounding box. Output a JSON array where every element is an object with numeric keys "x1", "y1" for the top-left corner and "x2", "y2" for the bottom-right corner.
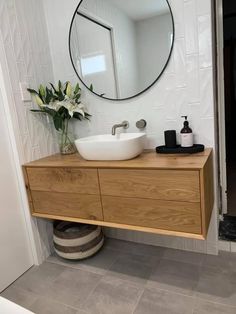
[{"x1": 136, "y1": 14, "x2": 173, "y2": 90}]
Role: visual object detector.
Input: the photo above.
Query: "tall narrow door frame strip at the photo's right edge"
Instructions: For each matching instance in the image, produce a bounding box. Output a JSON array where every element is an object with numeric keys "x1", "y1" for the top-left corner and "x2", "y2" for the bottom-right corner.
[{"x1": 215, "y1": 0, "x2": 228, "y2": 216}]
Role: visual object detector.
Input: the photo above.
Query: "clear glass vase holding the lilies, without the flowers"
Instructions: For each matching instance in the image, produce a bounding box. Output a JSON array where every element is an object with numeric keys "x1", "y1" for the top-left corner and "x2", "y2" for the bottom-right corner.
[{"x1": 59, "y1": 120, "x2": 76, "y2": 155}]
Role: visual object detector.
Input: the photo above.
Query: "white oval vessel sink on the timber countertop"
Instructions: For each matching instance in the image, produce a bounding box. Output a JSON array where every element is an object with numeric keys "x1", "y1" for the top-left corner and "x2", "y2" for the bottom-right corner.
[{"x1": 75, "y1": 133, "x2": 146, "y2": 160}]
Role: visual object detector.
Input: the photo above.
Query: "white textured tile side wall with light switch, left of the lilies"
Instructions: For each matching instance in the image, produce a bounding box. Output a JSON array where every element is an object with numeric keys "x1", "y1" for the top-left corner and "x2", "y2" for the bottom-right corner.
[{"x1": 0, "y1": 0, "x2": 57, "y2": 257}]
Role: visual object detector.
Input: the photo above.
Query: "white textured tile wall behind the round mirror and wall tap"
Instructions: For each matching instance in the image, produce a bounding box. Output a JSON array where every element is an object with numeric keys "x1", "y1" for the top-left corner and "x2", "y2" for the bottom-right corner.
[{"x1": 43, "y1": 0, "x2": 218, "y2": 254}]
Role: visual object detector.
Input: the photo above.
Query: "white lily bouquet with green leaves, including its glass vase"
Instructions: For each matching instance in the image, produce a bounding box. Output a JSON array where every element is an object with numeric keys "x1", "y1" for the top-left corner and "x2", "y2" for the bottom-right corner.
[{"x1": 28, "y1": 81, "x2": 91, "y2": 154}]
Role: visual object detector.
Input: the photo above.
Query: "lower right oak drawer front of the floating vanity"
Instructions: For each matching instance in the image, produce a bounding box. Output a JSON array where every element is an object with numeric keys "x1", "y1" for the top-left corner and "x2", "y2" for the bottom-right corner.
[{"x1": 102, "y1": 196, "x2": 202, "y2": 234}]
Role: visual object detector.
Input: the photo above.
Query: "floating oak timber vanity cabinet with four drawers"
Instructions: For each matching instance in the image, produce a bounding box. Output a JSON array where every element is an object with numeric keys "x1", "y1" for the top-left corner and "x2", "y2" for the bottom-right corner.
[{"x1": 23, "y1": 148, "x2": 214, "y2": 239}]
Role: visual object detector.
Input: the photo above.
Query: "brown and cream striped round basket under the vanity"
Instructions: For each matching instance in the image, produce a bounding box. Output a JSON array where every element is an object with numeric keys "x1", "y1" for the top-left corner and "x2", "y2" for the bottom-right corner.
[{"x1": 53, "y1": 221, "x2": 104, "y2": 260}]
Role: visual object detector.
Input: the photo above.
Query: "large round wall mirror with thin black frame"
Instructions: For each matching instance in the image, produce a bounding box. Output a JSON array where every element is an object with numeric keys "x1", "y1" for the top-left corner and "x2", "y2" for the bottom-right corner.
[{"x1": 69, "y1": 0, "x2": 174, "y2": 100}]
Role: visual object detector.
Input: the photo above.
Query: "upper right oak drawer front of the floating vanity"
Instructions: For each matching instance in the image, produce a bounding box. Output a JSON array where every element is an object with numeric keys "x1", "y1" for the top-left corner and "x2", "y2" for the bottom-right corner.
[{"x1": 99, "y1": 169, "x2": 200, "y2": 202}]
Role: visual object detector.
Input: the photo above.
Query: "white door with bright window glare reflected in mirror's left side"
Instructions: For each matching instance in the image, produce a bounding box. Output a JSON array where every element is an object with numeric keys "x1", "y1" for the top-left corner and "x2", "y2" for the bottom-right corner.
[{"x1": 73, "y1": 15, "x2": 117, "y2": 98}]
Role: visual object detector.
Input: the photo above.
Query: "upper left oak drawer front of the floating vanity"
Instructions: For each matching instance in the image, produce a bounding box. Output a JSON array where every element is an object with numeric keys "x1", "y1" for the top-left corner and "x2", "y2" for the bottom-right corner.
[{"x1": 27, "y1": 168, "x2": 99, "y2": 195}]
